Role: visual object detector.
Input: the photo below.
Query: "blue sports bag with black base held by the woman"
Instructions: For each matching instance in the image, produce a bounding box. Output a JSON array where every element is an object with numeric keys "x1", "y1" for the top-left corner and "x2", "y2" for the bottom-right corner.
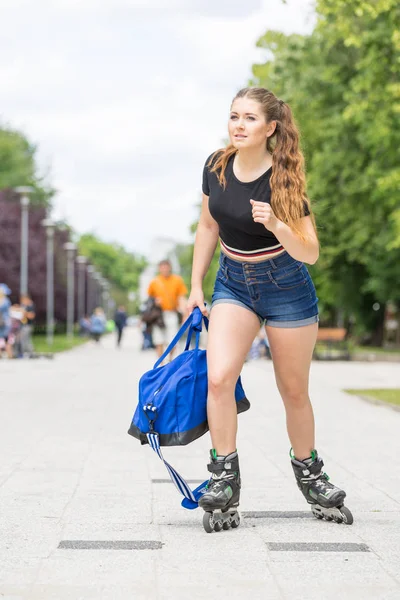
[{"x1": 128, "y1": 307, "x2": 250, "y2": 446}]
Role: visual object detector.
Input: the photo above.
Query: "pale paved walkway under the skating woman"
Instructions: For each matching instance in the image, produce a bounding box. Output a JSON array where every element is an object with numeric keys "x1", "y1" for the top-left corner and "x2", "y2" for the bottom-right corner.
[{"x1": 0, "y1": 330, "x2": 400, "y2": 600}]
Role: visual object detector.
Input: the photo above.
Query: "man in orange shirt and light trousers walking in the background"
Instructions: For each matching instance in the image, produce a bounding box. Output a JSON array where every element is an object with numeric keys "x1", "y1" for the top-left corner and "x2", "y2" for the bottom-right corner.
[{"x1": 147, "y1": 260, "x2": 188, "y2": 358}]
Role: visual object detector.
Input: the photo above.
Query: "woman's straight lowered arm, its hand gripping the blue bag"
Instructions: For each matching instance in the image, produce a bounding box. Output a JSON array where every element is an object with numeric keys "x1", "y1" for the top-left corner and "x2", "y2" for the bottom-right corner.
[{"x1": 188, "y1": 194, "x2": 219, "y2": 314}]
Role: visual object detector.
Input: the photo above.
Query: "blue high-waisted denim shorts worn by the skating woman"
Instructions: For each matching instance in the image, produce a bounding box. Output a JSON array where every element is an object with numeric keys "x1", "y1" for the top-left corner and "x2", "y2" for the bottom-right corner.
[{"x1": 211, "y1": 252, "x2": 318, "y2": 328}]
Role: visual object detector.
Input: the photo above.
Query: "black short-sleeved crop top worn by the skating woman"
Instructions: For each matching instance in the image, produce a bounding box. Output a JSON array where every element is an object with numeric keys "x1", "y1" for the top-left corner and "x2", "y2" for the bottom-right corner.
[{"x1": 203, "y1": 156, "x2": 310, "y2": 253}]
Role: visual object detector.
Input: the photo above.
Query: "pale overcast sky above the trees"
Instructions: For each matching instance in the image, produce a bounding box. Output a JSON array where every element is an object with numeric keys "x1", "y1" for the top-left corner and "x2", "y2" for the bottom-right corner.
[{"x1": 0, "y1": 0, "x2": 314, "y2": 254}]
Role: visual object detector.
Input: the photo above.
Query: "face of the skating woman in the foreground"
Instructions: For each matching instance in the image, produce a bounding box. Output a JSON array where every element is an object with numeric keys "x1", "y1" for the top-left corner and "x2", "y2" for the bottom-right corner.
[{"x1": 228, "y1": 96, "x2": 276, "y2": 150}]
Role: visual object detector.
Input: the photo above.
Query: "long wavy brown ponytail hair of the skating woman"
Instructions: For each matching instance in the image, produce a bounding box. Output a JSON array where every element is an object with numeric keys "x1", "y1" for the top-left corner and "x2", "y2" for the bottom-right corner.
[{"x1": 208, "y1": 87, "x2": 316, "y2": 241}]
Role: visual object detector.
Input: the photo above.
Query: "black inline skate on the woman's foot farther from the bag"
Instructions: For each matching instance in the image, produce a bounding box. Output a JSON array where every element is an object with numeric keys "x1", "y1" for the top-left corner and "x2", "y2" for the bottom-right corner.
[{"x1": 290, "y1": 450, "x2": 353, "y2": 525}]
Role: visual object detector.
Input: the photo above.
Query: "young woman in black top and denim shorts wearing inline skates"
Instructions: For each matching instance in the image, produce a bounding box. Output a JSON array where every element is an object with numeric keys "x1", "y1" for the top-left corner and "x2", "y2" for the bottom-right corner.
[{"x1": 188, "y1": 88, "x2": 352, "y2": 523}]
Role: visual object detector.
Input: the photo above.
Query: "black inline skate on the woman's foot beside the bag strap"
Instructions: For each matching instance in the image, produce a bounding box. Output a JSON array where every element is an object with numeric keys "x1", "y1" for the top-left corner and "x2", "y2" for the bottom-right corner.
[{"x1": 199, "y1": 450, "x2": 240, "y2": 533}]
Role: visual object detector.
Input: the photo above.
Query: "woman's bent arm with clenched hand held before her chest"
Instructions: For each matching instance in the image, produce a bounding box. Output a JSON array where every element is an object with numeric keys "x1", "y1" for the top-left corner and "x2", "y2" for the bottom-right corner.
[{"x1": 250, "y1": 200, "x2": 319, "y2": 265}]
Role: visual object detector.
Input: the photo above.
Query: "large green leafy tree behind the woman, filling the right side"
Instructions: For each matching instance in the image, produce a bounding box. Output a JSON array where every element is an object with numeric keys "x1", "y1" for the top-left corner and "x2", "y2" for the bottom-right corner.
[{"x1": 251, "y1": 0, "x2": 400, "y2": 342}]
